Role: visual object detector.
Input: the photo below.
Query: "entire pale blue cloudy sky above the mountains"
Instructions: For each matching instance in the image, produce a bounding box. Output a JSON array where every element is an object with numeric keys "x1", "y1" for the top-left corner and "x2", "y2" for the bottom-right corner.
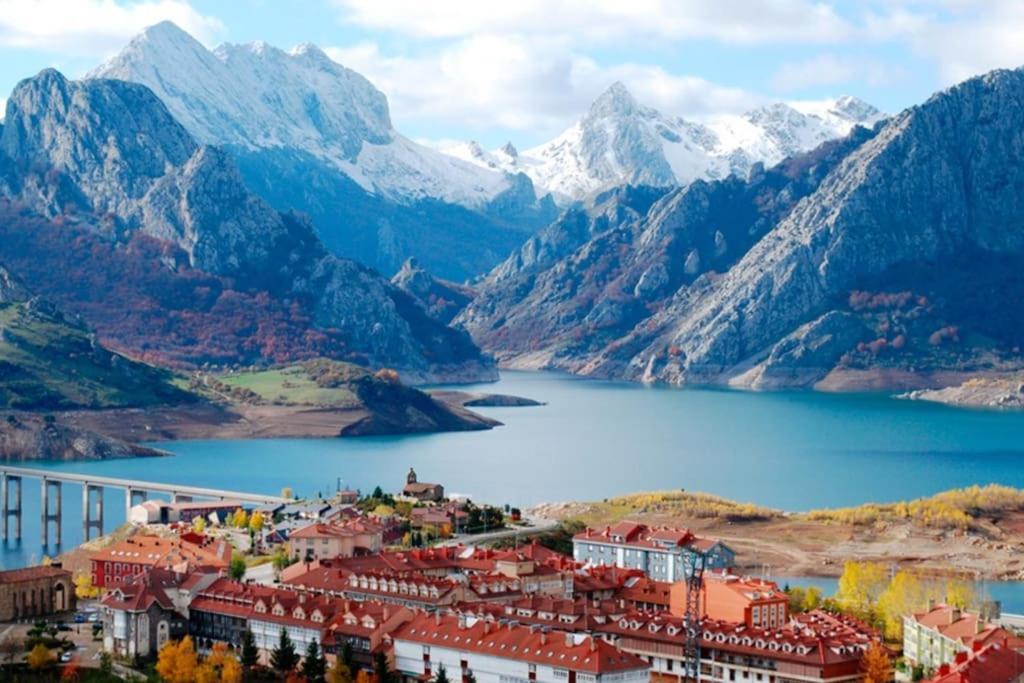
[{"x1": 0, "y1": 0, "x2": 1024, "y2": 146}]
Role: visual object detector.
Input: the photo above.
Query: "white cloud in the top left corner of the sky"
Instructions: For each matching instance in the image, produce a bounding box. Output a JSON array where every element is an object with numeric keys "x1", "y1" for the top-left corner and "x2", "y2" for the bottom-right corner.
[{"x1": 0, "y1": 0, "x2": 223, "y2": 56}]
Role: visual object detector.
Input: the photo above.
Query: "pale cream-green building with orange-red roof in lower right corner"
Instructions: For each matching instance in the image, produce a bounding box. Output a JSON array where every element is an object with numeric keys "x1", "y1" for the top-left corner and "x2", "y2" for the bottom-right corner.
[{"x1": 903, "y1": 604, "x2": 1024, "y2": 669}]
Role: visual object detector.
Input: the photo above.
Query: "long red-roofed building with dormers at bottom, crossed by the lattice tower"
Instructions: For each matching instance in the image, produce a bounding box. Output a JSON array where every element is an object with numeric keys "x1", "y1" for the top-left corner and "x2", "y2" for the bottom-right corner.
[{"x1": 597, "y1": 611, "x2": 878, "y2": 683}]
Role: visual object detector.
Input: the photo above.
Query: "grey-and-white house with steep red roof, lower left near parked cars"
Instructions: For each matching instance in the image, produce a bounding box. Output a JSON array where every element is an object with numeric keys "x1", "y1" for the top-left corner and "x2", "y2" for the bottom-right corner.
[{"x1": 101, "y1": 567, "x2": 218, "y2": 657}]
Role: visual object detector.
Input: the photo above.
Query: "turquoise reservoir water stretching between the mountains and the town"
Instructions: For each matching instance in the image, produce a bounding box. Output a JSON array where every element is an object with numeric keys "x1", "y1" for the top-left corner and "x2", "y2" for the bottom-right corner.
[{"x1": 6, "y1": 372, "x2": 1024, "y2": 609}]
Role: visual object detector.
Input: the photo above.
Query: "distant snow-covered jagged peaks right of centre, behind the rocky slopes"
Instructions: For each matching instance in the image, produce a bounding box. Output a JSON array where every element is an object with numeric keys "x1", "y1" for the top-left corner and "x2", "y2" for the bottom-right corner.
[{"x1": 447, "y1": 82, "x2": 882, "y2": 203}]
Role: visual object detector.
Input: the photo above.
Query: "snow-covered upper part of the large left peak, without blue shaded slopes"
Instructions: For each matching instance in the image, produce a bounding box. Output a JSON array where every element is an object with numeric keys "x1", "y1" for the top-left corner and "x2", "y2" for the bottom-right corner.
[{"x1": 88, "y1": 22, "x2": 515, "y2": 208}]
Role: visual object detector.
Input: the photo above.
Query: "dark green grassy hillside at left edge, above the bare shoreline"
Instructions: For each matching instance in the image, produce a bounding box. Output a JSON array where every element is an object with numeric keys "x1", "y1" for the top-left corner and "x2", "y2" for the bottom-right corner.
[{"x1": 0, "y1": 303, "x2": 190, "y2": 410}]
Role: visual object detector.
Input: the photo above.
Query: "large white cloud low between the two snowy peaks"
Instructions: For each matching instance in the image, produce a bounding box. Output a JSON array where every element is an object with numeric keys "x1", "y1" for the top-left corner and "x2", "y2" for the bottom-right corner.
[{"x1": 327, "y1": 35, "x2": 758, "y2": 134}]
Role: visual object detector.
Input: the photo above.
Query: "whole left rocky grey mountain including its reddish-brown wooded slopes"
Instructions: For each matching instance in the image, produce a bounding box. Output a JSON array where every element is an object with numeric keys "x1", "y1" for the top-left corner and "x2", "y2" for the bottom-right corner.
[{"x1": 0, "y1": 70, "x2": 494, "y2": 381}]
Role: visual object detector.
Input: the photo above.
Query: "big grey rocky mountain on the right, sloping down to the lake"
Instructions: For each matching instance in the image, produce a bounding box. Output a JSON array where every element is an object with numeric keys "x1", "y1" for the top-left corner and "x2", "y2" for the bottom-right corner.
[{"x1": 457, "y1": 70, "x2": 1024, "y2": 388}]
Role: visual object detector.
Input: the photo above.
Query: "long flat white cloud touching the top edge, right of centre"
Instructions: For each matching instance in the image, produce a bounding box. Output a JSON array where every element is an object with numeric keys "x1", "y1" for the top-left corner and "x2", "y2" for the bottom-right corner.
[{"x1": 334, "y1": 0, "x2": 851, "y2": 44}]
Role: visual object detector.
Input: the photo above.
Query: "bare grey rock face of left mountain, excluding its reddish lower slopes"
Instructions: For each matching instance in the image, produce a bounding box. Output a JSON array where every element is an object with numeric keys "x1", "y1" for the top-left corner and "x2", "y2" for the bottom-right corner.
[{"x1": 0, "y1": 70, "x2": 494, "y2": 381}]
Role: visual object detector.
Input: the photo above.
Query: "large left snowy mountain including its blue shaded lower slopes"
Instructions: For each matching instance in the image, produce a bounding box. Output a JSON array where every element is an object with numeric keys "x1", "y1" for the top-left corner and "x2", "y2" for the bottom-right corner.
[{"x1": 89, "y1": 23, "x2": 555, "y2": 279}]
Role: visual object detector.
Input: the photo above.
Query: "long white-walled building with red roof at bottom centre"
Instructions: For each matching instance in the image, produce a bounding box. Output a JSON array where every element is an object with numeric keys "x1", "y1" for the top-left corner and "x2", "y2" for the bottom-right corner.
[{"x1": 392, "y1": 613, "x2": 650, "y2": 683}]
